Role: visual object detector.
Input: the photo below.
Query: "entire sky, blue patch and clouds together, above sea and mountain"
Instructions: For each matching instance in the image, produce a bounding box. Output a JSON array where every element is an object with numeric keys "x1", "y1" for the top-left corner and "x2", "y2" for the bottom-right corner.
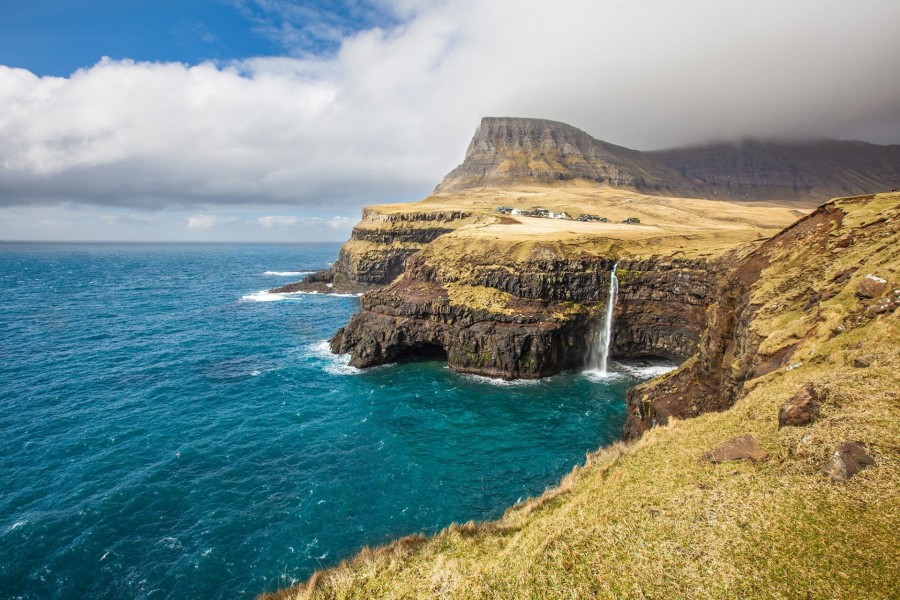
[{"x1": 0, "y1": 0, "x2": 900, "y2": 242}]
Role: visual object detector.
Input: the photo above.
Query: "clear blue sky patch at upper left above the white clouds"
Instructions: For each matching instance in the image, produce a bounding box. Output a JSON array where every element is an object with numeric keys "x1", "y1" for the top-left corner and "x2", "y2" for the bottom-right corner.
[{"x1": 0, "y1": 0, "x2": 395, "y2": 76}]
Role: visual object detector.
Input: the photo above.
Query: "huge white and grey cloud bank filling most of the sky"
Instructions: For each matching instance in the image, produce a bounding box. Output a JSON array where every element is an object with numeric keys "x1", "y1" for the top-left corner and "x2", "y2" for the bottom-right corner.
[{"x1": 0, "y1": 0, "x2": 900, "y2": 223}]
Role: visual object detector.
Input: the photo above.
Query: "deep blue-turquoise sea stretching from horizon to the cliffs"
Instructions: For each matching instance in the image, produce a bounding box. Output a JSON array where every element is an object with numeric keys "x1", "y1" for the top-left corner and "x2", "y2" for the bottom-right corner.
[{"x1": 0, "y1": 244, "x2": 672, "y2": 599}]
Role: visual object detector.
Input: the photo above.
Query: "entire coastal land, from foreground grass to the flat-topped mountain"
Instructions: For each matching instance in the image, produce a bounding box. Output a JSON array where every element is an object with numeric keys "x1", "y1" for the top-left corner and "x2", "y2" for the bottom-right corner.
[{"x1": 262, "y1": 119, "x2": 900, "y2": 598}]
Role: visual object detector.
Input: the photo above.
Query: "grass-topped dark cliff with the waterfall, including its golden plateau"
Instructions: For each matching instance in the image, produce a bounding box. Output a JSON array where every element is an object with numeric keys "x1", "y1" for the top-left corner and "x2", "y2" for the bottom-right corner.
[{"x1": 331, "y1": 189, "x2": 795, "y2": 379}]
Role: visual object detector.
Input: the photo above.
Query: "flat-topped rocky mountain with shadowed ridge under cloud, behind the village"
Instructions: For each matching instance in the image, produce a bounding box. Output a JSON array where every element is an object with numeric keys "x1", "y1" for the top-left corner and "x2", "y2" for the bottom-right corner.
[{"x1": 435, "y1": 117, "x2": 900, "y2": 204}]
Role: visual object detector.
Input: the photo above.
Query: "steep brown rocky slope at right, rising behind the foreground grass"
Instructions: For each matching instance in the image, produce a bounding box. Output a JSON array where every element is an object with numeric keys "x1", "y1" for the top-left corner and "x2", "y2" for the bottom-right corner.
[{"x1": 623, "y1": 193, "x2": 900, "y2": 439}]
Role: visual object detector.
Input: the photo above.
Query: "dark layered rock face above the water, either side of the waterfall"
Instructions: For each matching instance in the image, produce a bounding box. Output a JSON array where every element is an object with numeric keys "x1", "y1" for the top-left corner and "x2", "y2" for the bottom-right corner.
[{"x1": 331, "y1": 253, "x2": 725, "y2": 379}]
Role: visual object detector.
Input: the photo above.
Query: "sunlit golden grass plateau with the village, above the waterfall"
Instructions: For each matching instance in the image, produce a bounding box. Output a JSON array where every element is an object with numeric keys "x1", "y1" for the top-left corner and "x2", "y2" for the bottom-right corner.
[{"x1": 360, "y1": 183, "x2": 808, "y2": 264}]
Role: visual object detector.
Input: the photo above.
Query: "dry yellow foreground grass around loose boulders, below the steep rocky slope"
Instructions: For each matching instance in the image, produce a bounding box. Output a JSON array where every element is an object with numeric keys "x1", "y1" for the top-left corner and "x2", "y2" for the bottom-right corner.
[{"x1": 268, "y1": 332, "x2": 900, "y2": 598}]
